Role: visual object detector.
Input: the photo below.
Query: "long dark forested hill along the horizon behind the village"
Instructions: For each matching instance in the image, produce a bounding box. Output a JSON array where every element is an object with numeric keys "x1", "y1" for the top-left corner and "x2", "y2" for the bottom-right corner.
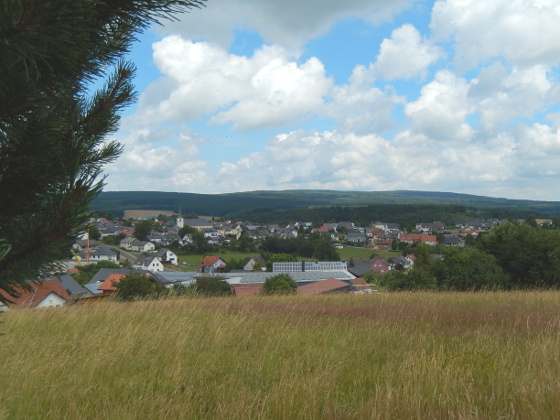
[{"x1": 89, "y1": 190, "x2": 560, "y2": 221}]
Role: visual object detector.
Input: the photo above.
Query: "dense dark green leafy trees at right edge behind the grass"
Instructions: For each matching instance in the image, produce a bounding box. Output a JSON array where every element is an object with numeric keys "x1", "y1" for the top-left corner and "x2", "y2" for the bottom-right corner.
[{"x1": 375, "y1": 222, "x2": 560, "y2": 291}]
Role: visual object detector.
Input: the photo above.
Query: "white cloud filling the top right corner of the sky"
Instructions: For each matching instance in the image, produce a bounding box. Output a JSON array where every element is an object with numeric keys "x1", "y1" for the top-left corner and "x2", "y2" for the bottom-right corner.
[{"x1": 430, "y1": 0, "x2": 560, "y2": 70}]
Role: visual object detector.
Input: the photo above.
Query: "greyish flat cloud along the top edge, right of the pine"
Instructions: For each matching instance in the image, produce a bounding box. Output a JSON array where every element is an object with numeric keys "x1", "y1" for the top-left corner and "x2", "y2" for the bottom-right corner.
[{"x1": 156, "y1": 0, "x2": 417, "y2": 50}]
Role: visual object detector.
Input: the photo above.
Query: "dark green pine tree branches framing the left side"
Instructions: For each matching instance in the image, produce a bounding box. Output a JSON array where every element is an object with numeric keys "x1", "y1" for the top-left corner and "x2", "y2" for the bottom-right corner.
[{"x1": 0, "y1": 0, "x2": 205, "y2": 300}]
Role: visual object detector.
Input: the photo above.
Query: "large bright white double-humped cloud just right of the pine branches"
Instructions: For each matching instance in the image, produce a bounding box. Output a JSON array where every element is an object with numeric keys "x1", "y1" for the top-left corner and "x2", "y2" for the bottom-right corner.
[{"x1": 131, "y1": 36, "x2": 332, "y2": 129}]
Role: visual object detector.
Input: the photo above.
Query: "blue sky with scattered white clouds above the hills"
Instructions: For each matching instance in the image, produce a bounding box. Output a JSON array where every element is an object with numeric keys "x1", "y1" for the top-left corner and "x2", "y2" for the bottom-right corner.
[{"x1": 105, "y1": 0, "x2": 560, "y2": 200}]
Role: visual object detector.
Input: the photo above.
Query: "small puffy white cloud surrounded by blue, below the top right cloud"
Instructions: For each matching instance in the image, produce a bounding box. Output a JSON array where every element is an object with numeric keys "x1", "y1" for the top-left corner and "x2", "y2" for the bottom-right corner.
[{"x1": 374, "y1": 24, "x2": 444, "y2": 80}]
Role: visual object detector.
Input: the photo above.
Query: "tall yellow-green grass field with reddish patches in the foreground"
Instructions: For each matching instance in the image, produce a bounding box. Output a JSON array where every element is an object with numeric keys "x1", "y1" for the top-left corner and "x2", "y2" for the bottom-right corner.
[{"x1": 0, "y1": 292, "x2": 560, "y2": 420}]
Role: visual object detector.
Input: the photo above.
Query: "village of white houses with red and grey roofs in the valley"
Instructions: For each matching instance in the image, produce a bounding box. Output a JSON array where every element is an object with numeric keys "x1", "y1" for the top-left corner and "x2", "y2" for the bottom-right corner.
[{"x1": 1, "y1": 214, "x2": 551, "y2": 310}]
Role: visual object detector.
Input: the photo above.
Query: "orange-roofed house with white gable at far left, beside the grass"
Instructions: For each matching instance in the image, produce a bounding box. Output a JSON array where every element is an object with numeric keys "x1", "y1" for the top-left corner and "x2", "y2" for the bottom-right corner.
[{"x1": 0, "y1": 279, "x2": 70, "y2": 310}]
